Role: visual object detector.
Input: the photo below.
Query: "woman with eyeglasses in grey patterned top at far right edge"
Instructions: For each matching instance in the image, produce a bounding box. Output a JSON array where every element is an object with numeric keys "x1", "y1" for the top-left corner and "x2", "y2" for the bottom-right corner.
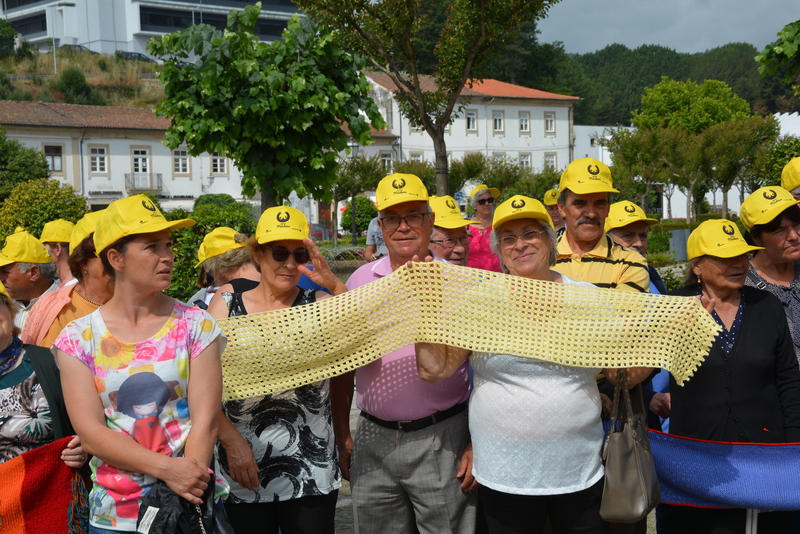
[{"x1": 742, "y1": 186, "x2": 800, "y2": 362}]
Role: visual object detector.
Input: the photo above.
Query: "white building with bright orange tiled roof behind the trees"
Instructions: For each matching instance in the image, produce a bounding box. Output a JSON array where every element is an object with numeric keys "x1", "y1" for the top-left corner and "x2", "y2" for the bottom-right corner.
[{"x1": 363, "y1": 73, "x2": 580, "y2": 173}]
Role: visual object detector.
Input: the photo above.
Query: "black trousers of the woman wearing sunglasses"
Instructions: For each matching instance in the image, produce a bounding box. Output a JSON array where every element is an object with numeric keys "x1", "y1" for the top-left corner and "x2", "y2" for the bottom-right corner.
[{"x1": 225, "y1": 490, "x2": 339, "y2": 534}]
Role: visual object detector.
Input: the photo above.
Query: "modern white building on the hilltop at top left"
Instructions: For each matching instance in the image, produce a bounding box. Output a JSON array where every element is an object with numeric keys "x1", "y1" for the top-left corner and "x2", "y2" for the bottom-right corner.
[{"x1": 0, "y1": 0, "x2": 297, "y2": 54}]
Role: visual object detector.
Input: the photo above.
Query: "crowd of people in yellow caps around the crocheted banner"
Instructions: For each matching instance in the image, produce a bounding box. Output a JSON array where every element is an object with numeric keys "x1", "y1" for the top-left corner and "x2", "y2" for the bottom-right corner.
[{"x1": 0, "y1": 158, "x2": 800, "y2": 534}]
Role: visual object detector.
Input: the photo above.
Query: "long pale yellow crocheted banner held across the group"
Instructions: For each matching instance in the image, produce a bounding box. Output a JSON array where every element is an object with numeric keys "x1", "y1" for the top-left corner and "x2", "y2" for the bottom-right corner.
[{"x1": 219, "y1": 262, "x2": 720, "y2": 400}]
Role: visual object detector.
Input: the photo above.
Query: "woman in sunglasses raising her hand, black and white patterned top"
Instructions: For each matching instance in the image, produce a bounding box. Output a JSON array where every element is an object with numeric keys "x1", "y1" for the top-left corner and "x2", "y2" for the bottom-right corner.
[{"x1": 208, "y1": 206, "x2": 347, "y2": 534}]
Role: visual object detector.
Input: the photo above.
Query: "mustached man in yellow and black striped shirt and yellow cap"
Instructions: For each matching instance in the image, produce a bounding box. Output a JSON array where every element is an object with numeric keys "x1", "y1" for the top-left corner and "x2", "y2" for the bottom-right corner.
[{"x1": 553, "y1": 158, "x2": 650, "y2": 293}]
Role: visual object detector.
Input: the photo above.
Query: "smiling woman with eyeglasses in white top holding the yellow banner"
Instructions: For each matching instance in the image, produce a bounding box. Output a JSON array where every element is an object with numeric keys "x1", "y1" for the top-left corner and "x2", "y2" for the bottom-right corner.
[{"x1": 415, "y1": 195, "x2": 651, "y2": 534}]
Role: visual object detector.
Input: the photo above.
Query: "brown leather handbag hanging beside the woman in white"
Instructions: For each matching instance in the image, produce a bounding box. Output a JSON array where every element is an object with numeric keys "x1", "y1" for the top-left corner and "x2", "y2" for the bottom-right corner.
[{"x1": 600, "y1": 369, "x2": 661, "y2": 523}]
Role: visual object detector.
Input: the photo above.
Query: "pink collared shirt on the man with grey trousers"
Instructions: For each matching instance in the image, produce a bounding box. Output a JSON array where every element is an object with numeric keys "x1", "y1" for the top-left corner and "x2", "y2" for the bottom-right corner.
[{"x1": 347, "y1": 252, "x2": 469, "y2": 421}]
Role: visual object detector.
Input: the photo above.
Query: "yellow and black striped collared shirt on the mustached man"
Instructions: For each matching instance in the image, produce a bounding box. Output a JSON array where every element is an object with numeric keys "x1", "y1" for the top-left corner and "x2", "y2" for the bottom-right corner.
[{"x1": 553, "y1": 234, "x2": 650, "y2": 293}]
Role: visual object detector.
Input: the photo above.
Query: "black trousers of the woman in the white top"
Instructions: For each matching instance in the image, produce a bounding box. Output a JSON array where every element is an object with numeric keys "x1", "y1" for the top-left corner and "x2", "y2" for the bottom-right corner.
[{"x1": 478, "y1": 479, "x2": 605, "y2": 534}]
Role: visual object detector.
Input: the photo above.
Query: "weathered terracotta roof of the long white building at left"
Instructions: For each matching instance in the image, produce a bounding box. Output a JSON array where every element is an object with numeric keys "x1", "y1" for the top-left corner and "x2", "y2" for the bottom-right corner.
[{"x1": 0, "y1": 100, "x2": 170, "y2": 131}]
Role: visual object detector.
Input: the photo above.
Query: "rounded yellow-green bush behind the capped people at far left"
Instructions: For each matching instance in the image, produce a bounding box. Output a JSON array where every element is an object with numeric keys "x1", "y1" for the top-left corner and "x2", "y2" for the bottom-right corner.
[{"x1": 0, "y1": 179, "x2": 87, "y2": 241}]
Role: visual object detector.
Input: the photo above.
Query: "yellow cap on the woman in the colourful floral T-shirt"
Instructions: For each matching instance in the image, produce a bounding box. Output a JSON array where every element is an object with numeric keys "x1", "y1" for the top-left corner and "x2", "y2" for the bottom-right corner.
[{"x1": 94, "y1": 195, "x2": 195, "y2": 255}]
